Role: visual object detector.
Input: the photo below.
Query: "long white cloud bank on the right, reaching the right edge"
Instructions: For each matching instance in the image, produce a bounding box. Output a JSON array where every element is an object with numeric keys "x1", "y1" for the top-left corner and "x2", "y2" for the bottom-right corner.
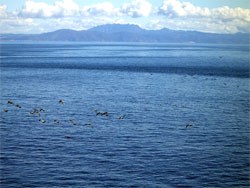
[{"x1": 158, "y1": 0, "x2": 250, "y2": 33}]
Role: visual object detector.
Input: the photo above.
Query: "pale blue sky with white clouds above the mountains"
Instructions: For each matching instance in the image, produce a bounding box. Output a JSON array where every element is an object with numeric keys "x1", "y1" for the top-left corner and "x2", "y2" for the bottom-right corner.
[{"x1": 0, "y1": 0, "x2": 250, "y2": 33}]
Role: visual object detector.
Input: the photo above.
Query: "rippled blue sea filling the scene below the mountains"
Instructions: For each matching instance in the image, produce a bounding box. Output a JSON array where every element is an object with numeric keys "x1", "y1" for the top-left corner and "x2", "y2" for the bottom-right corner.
[{"x1": 0, "y1": 42, "x2": 250, "y2": 188}]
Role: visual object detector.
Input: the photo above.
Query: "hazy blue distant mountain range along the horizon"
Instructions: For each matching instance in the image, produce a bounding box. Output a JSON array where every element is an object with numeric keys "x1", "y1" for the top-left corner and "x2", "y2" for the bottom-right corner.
[{"x1": 0, "y1": 24, "x2": 250, "y2": 44}]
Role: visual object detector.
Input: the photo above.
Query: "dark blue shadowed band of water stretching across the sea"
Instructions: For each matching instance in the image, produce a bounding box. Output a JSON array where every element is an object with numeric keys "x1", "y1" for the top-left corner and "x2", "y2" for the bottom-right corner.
[{"x1": 0, "y1": 63, "x2": 250, "y2": 78}]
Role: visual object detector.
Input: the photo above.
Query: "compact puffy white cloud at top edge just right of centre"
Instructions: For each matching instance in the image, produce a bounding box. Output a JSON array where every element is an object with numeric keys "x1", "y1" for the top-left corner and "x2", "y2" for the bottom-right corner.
[{"x1": 121, "y1": 0, "x2": 152, "y2": 17}]
